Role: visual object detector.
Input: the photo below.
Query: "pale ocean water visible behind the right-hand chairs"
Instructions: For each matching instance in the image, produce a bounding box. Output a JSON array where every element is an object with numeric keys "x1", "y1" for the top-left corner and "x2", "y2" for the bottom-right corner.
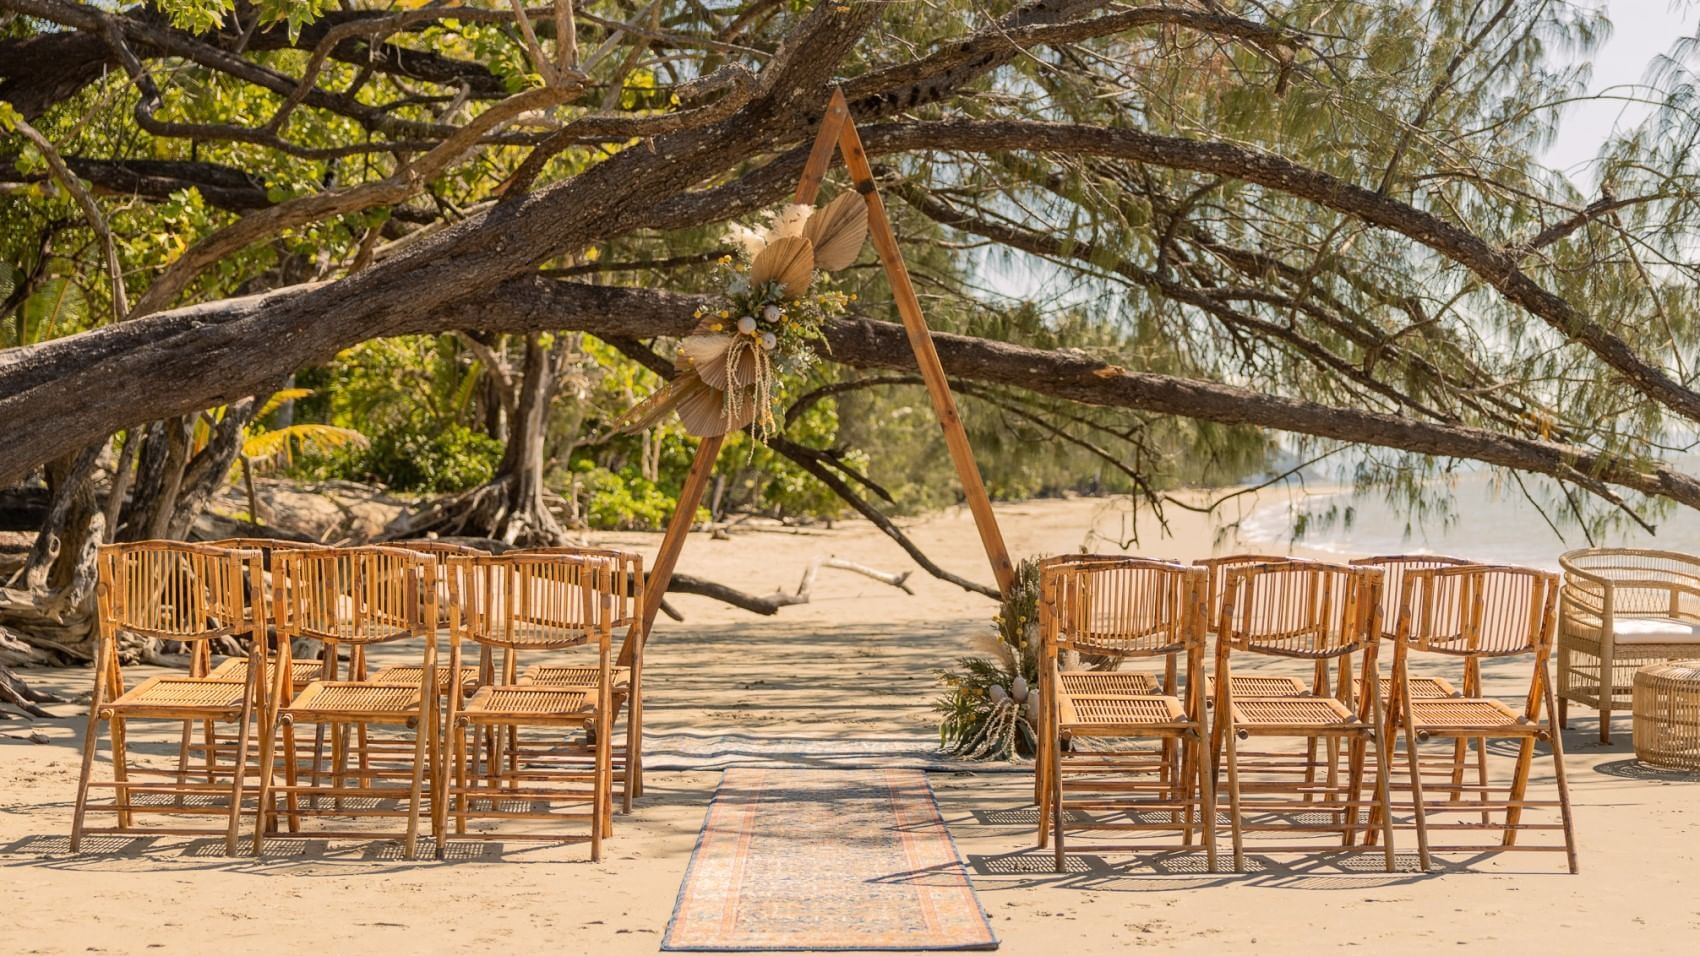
[{"x1": 1239, "y1": 461, "x2": 1700, "y2": 570}]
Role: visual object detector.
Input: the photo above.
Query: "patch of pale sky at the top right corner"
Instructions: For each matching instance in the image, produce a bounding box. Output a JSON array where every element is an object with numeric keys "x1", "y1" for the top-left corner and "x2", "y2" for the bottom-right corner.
[{"x1": 1545, "y1": 0, "x2": 1700, "y2": 181}]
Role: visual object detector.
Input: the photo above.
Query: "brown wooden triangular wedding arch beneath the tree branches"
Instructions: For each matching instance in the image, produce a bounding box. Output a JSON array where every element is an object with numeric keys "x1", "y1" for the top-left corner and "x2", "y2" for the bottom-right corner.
[{"x1": 619, "y1": 90, "x2": 1015, "y2": 667}]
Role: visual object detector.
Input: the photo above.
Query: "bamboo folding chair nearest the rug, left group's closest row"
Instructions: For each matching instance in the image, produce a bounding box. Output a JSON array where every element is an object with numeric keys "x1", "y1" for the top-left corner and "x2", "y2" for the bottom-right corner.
[{"x1": 437, "y1": 553, "x2": 622, "y2": 861}]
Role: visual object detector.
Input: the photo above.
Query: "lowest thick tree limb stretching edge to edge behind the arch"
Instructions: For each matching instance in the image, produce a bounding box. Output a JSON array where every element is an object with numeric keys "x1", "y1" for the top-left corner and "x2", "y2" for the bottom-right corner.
[{"x1": 0, "y1": 269, "x2": 1700, "y2": 509}]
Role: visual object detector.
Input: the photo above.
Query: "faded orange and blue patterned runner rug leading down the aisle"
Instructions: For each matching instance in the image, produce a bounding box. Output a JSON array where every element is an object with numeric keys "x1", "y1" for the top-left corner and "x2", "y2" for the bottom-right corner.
[{"x1": 661, "y1": 769, "x2": 998, "y2": 953}]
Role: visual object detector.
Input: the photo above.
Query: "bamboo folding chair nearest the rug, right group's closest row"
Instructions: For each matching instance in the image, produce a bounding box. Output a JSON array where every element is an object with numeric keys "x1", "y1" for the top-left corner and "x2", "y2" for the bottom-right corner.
[{"x1": 1039, "y1": 558, "x2": 1216, "y2": 873}]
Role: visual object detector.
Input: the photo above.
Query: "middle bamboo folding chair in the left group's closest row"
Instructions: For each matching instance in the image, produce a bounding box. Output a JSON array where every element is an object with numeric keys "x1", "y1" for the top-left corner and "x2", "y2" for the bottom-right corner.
[{"x1": 253, "y1": 548, "x2": 439, "y2": 859}]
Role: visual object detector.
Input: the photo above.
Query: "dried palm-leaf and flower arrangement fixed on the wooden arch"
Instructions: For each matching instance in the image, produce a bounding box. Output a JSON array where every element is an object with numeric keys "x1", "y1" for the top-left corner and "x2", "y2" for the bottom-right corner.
[{"x1": 617, "y1": 192, "x2": 867, "y2": 437}]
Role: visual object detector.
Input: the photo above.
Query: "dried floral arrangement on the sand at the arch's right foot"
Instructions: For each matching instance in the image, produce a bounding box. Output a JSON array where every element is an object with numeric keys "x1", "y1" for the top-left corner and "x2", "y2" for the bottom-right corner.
[{"x1": 935, "y1": 558, "x2": 1040, "y2": 760}]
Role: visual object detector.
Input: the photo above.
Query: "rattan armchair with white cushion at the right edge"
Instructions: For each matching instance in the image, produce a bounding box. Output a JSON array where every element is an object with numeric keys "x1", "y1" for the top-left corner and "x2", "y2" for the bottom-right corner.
[{"x1": 1557, "y1": 548, "x2": 1700, "y2": 743}]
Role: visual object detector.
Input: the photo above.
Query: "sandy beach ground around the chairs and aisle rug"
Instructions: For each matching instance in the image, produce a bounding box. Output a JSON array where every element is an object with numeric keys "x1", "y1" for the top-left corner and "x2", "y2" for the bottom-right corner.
[{"x1": 0, "y1": 500, "x2": 1700, "y2": 956}]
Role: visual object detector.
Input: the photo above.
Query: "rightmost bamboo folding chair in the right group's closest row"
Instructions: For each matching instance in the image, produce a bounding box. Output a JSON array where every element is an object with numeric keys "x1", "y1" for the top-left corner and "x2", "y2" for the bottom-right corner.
[{"x1": 1389, "y1": 565, "x2": 1576, "y2": 873}]
